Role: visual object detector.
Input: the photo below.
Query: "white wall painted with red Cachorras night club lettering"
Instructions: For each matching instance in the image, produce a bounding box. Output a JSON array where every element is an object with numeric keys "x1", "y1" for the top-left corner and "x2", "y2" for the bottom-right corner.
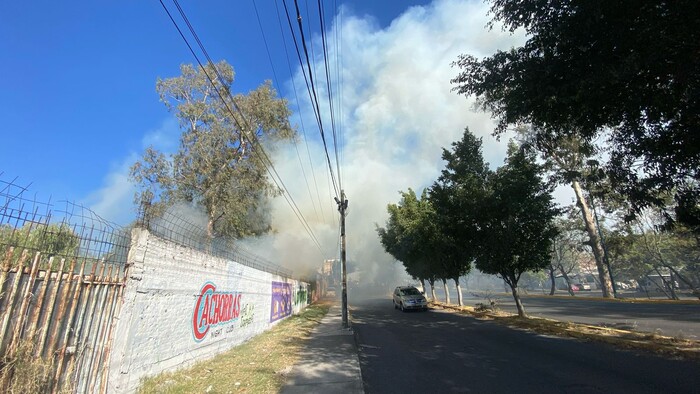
[{"x1": 108, "y1": 229, "x2": 308, "y2": 393}]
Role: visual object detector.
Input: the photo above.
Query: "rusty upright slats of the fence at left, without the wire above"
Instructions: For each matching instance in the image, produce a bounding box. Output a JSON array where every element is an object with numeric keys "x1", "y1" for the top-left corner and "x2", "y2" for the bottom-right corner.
[{"x1": 0, "y1": 246, "x2": 125, "y2": 393}]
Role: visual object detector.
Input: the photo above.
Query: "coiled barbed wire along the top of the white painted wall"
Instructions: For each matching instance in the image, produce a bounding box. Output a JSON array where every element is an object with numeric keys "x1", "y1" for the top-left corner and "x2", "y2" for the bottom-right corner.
[{"x1": 136, "y1": 203, "x2": 292, "y2": 278}]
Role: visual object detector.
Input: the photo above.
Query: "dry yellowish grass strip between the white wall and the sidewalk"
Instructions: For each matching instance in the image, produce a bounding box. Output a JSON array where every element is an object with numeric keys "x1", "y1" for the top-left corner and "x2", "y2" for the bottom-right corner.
[{"x1": 139, "y1": 302, "x2": 330, "y2": 393}]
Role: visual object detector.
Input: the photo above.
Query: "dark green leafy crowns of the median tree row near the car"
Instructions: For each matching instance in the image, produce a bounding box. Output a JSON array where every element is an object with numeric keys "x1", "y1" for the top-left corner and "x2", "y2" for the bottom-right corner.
[{"x1": 377, "y1": 129, "x2": 558, "y2": 292}]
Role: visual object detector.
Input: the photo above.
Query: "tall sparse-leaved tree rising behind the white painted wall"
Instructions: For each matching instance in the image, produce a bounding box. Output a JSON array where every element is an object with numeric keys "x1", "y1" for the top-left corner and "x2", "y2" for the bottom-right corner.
[{"x1": 130, "y1": 61, "x2": 296, "y2": 237}]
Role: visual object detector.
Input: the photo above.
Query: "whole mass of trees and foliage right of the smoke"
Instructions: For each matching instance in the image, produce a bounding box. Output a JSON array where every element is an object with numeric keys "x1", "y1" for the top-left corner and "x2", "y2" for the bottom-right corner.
[{"x1": 377, "y1": 0, "x2": 700, "y2": 317}]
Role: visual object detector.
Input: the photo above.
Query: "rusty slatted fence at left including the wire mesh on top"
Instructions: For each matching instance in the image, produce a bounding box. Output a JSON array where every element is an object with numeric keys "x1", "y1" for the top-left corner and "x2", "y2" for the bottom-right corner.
[{"x1": 0, "y1": 180, "x2": 129, "y2": 392}]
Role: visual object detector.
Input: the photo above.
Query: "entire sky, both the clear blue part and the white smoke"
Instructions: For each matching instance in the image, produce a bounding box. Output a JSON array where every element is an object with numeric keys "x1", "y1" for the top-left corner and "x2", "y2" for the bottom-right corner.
[{"x1": 0, "y1": 0, "x2": 540, "y2": 278}]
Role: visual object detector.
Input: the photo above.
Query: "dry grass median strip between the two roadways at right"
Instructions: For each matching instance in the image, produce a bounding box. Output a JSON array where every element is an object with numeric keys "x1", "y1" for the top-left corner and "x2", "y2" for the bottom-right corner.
[{"x1": 433, "y1": 303, "x2": 700, "y2": 360}]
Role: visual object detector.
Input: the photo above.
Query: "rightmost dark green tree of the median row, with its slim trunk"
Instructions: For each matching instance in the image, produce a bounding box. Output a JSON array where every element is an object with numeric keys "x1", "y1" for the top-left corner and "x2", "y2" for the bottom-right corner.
[{"x1": 476, "y1": 144, "x2": 558, "y2": 317}]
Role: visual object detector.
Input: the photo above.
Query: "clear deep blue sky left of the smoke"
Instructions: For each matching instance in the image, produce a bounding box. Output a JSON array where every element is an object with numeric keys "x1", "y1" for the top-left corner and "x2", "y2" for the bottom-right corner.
[{"x1": 0, "y1": 0, "x2": 430, "y2": 208}]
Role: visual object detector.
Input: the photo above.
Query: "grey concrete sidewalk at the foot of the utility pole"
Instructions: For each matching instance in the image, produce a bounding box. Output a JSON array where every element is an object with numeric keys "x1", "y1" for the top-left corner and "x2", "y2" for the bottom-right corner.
[{"x1": 281, "y1": 299, "x2": 364, "y2": 394}]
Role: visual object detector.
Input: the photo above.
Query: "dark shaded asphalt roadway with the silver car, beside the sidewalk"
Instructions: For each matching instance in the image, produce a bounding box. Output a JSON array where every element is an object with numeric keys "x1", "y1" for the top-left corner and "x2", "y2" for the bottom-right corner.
[{"x1": 350, "y1": 298, "x2": 700, "y2": 394}]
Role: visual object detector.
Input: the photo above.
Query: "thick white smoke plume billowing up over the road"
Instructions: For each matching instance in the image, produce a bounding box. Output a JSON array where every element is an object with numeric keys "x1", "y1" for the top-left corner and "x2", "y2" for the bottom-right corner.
[{"x1": 256, "y1": 0, "x2": 524, "y2": 286}]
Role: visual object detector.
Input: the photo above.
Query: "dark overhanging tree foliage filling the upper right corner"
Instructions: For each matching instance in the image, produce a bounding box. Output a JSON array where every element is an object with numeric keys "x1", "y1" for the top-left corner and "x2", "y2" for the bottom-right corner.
[{"x1": 453, "y1": 0, "x2": 700, "y2": 229}]
